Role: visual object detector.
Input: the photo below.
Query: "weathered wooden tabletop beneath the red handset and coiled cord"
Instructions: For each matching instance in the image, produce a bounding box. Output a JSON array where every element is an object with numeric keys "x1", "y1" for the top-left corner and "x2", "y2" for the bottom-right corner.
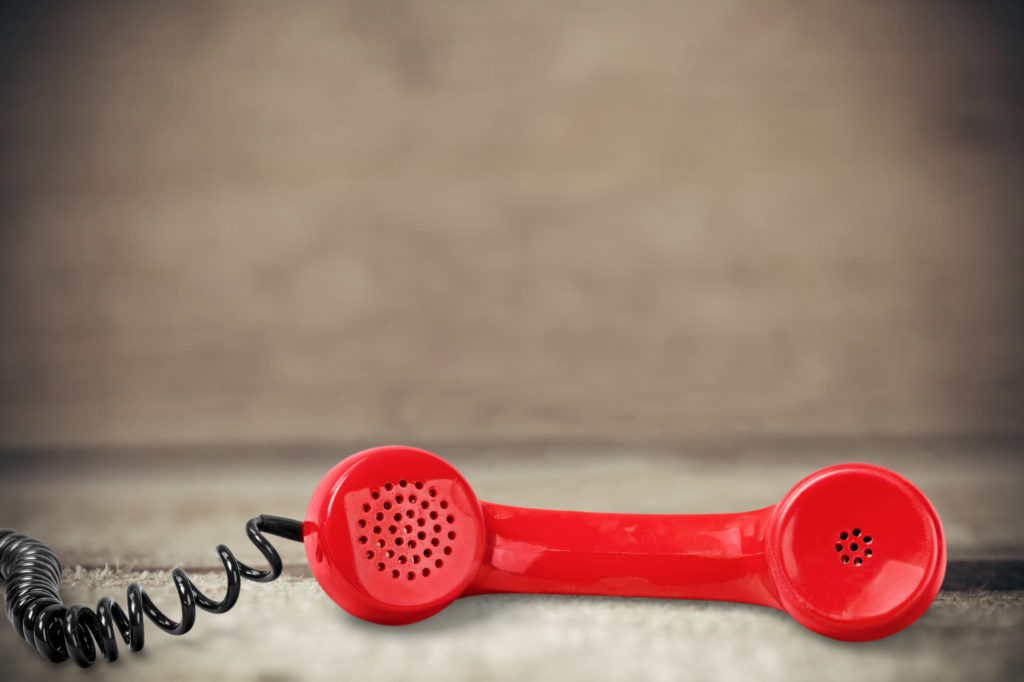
[{"x1": 0, "y1": 439, "x2": 1024, "y2": 680}]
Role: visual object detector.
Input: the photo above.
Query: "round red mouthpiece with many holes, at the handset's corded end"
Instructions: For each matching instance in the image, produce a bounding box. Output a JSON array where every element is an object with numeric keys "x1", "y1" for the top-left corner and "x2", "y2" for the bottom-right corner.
[{"x1": 303, "y1": 446, "x2": 485, "y2": 625}]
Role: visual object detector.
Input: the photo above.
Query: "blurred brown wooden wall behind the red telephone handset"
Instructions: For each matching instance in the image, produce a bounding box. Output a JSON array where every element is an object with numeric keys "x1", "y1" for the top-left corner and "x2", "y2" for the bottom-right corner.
[{"x1": 0, "y1": 1, "x2": 1024, "y2": 447}]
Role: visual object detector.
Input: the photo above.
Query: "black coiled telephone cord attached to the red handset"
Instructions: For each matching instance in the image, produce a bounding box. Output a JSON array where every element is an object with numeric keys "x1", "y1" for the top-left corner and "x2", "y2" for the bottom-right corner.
[{"x1": 0, "y1": 514, "x2": 302, "y2": 668}]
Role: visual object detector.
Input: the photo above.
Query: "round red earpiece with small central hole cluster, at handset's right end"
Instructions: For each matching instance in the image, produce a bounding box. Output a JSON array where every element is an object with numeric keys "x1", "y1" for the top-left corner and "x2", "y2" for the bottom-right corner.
[{"x1": 766, "y1": 464, "x2": 946, "y2": 641}]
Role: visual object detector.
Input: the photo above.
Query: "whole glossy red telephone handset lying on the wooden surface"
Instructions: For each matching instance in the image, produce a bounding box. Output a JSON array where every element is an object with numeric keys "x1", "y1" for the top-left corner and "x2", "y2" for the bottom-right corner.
[{"x1": 304, "y1": 446, "x2": 945, "y2": 640}]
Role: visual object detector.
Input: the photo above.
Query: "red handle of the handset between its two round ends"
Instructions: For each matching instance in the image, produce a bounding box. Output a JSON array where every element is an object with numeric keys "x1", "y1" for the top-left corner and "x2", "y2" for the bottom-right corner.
[{"x1": 466, "y1": 501, "x2": 779, "y2": 608}]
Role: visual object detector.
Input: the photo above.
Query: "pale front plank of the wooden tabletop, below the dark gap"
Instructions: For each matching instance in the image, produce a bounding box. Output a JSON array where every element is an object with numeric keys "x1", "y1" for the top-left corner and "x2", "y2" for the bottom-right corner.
[{"x1": 8, "y1": 571, "x2": 1024, "y2": 682}]
